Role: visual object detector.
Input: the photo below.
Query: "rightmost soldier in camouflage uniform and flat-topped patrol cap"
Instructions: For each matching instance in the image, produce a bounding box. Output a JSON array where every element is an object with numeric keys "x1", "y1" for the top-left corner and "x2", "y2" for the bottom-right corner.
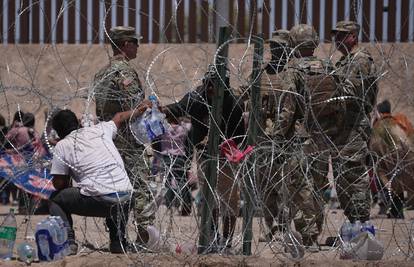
[{"x1": 332, "y1": 21, "x2": 378, "y2": 222}]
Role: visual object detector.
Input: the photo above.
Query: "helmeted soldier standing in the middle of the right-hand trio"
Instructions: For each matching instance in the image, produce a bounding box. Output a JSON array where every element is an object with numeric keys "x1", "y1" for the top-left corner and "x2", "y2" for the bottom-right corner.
[{"x1": 275, "y1": 24, "x2": 335, "y2": 252}]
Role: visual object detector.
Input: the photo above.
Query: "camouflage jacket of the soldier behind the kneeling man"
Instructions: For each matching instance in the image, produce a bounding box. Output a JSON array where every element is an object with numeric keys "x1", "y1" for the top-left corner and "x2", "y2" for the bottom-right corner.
[{"x1": 93, "y1": 55, "x2": 145, "y2": 148}]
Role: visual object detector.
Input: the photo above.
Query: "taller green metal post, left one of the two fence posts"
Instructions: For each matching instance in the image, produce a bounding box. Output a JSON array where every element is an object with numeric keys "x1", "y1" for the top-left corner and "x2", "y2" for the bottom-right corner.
[{"x1": 198, "y1": 27, "x2": 231, "y2": 254}]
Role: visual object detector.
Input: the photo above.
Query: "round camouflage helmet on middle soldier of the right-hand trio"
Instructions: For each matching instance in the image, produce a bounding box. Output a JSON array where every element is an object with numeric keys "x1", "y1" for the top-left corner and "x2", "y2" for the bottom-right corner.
[{"x1": 289, "y1": 24, "x2": 319, "y2": 49}]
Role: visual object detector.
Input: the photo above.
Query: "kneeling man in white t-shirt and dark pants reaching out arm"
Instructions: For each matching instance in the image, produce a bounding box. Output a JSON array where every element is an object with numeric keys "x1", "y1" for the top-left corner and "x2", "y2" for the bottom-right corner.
[{"x1": 49, "y1": 101, "x2": 151, "y2": 255}]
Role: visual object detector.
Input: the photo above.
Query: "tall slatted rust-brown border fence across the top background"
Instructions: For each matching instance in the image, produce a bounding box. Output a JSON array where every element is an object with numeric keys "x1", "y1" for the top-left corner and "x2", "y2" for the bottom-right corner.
[{"x1": 0, "y1": 0, "x2": 414, "y2": 44}]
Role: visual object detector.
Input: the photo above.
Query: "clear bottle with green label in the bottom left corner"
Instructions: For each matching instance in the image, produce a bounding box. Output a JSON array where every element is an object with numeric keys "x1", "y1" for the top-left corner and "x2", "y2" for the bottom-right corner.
[{"x1": 0, "y1": 209, "x2": 17, "y2": 260}]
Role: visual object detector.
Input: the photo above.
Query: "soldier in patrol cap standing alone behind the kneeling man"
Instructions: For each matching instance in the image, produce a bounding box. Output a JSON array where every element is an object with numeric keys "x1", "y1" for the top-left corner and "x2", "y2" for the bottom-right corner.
[{"x1": 93, "y1": 26, "x2": 155, "y2": 248}]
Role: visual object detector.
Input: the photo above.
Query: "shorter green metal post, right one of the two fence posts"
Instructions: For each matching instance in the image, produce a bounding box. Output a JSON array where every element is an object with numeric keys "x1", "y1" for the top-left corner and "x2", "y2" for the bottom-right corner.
[{"x1": 243, "y1": 35, "x2": 263, "y2": 256}]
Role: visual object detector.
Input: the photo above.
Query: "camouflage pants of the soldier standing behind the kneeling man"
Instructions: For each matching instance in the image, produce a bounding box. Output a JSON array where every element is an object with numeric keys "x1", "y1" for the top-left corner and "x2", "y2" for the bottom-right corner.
[{"x1": 119, "y1": 146, "x2": 156, "y2": 230}]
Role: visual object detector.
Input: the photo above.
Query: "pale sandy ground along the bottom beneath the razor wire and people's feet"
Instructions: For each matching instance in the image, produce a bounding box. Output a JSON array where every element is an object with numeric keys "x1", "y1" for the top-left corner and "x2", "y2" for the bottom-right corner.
[{"x1": 0, "y1": 202, "x2": 414, "y2": 267}]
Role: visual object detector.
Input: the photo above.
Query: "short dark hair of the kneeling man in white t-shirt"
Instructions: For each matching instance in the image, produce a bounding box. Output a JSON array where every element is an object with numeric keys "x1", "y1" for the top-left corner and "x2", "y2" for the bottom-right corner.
[{"x1": 52, "y1": 109, "x2": 79, "y2": 139}]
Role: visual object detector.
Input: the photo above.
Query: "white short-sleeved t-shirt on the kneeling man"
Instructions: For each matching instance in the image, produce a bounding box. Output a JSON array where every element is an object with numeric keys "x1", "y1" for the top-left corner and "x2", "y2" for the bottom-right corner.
[{"x1": 51, "y1": 121, "x2": 132, "y2": 196}]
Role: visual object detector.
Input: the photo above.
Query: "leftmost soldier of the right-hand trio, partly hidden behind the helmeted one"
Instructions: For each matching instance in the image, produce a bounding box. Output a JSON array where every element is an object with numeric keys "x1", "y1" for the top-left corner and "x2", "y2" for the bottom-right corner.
[{"x1": 257, "y1": 30, "x2": 293, "y2": 242}]
